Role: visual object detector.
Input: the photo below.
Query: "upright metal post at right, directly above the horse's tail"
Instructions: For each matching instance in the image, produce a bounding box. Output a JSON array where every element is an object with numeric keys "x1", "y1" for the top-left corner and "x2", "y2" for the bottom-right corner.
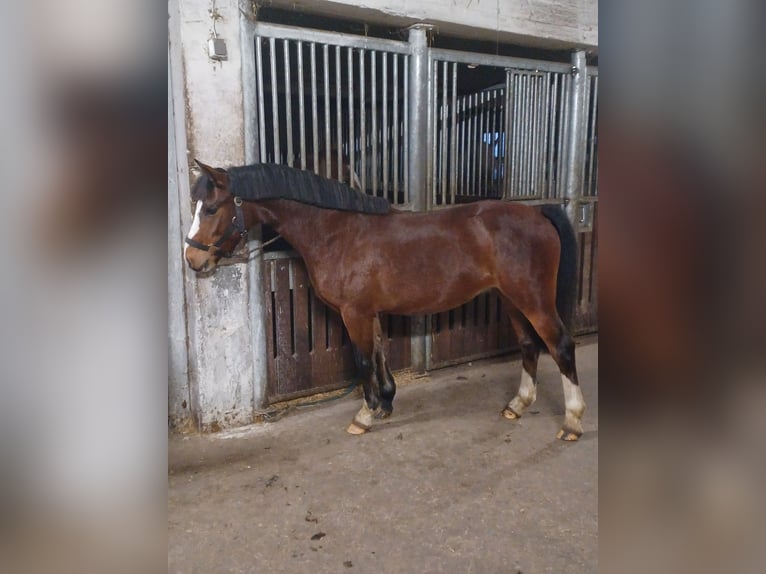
[{"x1": 564, "y1": 50, "x2": 588, "y2": 230}]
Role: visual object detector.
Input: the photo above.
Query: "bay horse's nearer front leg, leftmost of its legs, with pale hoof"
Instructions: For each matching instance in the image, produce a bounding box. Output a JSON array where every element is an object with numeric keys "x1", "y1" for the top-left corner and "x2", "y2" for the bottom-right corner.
[{"x1": 341, "y1": 308, "x2": 380, "y2": 435}]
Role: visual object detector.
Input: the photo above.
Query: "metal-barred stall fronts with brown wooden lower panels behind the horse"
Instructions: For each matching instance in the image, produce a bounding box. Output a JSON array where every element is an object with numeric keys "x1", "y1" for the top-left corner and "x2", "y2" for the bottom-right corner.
[{"x1": 171, "y1": 0, "x2": 598, "y2": 428}]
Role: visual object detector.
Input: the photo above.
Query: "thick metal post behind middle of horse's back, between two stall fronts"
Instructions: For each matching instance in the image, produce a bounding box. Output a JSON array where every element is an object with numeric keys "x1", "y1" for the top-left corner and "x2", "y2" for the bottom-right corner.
[{"x1": 405, "y1": 24, "x2": 431, "y2": 372}]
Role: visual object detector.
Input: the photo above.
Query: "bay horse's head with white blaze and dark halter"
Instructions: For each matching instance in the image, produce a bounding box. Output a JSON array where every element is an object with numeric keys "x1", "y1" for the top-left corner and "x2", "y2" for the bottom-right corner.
[{"x1": 185, "y1": 160, "x2": 247, "y2": 272}]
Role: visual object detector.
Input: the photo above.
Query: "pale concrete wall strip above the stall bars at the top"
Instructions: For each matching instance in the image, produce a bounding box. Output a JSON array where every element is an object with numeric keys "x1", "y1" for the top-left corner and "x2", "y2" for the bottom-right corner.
[{"x1": 264, "y1": 0, "x2": 598, "y2": 51}]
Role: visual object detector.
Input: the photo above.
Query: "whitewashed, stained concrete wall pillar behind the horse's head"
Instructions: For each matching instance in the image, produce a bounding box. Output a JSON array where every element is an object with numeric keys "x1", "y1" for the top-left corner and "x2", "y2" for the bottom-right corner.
[{"x1": 169, "y1": 0, "x2": 254, "y2": 430}]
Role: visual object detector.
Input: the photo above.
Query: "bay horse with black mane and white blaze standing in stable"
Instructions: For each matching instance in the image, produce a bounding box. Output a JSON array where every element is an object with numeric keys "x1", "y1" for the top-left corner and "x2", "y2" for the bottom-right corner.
[{"x1": 185, "y1": 160, "x2": 585, "y2": 440}]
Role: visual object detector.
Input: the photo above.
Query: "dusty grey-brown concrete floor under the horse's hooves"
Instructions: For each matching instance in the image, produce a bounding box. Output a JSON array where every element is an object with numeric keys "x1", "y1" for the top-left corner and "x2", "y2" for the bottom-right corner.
[{"x1": 168, "y1": 340, "x2": 598, "y2": 574}]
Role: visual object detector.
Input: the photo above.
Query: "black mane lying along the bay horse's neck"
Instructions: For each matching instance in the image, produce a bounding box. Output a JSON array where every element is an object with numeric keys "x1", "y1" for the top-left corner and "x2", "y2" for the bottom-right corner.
[{"x1": 226, "y1": 163, "x2": 390, "y2": 214}]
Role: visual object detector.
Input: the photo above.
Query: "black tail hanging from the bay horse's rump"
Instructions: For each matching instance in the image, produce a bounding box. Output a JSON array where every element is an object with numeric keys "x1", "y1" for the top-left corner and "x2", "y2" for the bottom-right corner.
[{"x1": 541, "y1": 205, "x2": 577, "y2": 330}]
